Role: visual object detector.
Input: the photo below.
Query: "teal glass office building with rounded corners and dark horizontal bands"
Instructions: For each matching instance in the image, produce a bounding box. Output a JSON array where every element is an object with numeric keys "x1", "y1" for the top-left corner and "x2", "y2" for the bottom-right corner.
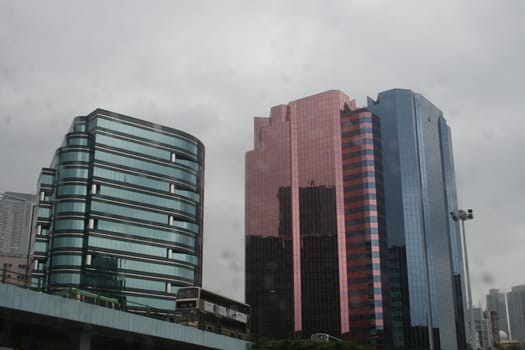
[{"x1": 32, "y1": 109, "x2": 204, "y2": 311}]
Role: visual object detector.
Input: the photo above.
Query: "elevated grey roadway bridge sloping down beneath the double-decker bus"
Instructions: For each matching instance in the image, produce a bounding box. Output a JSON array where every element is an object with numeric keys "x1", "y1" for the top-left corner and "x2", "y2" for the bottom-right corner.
[{"x1": 0, "y1": 284, "x2": 250, "y2": 350}]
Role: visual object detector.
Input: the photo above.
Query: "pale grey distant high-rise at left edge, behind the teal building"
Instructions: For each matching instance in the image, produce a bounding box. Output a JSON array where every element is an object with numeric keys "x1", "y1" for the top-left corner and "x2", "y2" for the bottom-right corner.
[{"x1": 0, "y1": 192, "x2": 36, "y2": 257}]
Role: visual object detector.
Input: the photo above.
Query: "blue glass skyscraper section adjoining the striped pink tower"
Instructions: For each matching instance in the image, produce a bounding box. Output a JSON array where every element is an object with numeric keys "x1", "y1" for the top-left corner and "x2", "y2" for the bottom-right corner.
[{"x1": 368, "y1": 89, "x2": 465, "y2": 349}]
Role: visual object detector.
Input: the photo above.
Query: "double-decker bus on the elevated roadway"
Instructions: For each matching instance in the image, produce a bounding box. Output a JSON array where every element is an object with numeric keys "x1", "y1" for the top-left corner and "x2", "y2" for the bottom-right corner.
[{"x1": 175, "y1": 287, "x2": 250, "y2": 339}]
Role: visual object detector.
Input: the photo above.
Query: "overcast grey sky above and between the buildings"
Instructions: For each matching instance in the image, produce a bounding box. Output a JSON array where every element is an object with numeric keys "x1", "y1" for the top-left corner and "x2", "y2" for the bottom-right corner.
[{"x1": 0, "y1": 0, "x2": 525, "y2": 303}]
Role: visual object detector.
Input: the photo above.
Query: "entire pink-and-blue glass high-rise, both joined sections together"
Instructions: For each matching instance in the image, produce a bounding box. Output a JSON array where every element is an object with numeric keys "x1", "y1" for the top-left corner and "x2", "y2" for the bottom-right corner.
[{"x1": 245, "y1": 89, "x2": 466, "y2": 349}]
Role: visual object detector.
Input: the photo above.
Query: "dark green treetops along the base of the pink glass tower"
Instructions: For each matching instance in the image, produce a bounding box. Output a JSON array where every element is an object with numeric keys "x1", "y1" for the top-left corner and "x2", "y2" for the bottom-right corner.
[{"x1": 252, "y1": 339, "x2": 373, "y2": 350}]
